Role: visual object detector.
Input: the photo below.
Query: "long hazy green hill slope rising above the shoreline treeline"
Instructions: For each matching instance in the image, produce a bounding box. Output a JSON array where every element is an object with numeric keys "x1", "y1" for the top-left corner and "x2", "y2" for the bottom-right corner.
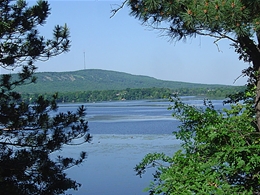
[{"x1": 16, "y1": 69, "x2": 238, "y2": 93}]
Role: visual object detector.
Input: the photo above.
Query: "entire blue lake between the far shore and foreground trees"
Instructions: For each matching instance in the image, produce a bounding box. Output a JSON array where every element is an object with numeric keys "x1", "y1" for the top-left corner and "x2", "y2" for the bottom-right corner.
[{"x1": 53, "y1": 98, "x2": 222, "y2": 195}]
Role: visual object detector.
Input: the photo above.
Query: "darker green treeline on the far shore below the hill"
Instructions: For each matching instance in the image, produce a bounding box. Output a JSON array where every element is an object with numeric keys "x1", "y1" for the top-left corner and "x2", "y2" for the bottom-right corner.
[{"x1": 22, "y1": 87, "x2": 245, "y2": 103}]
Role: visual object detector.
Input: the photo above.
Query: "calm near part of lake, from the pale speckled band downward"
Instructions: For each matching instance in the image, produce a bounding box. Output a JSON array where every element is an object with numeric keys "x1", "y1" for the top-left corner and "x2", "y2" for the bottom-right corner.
[{"x1": 62, "y1": 134, "x2": 180, "y2": 195}]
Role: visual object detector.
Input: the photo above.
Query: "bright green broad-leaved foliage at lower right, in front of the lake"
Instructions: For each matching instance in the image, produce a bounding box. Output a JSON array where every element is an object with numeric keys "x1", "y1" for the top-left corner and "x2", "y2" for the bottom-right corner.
[{"x1": 135, "y1": 94, "x2": 260, "y2": 194}]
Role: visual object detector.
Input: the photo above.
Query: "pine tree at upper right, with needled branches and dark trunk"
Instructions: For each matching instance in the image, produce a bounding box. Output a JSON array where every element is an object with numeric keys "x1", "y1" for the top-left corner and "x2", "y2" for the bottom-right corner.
[{"x1": 112, "y1": 0, "x2": 260, "y2": 131}]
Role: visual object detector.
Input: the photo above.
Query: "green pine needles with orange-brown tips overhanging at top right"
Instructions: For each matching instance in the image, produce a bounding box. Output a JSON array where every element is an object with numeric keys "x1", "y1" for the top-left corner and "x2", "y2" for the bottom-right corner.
[{"x1": 128, "y1": 0, "x2": 260, "y2": 39}]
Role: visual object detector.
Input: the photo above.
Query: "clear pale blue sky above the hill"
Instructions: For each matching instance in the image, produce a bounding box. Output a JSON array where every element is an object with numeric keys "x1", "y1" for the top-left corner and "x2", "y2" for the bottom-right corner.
[{"x1": 1, "y1": 0, "x2": 251, "y2": 85}]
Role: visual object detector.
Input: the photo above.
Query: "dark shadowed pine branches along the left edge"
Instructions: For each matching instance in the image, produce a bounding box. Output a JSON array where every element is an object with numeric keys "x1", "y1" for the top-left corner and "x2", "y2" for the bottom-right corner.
[{"x1": 0, "y1": 0, "x2": 91, "y2": 195}]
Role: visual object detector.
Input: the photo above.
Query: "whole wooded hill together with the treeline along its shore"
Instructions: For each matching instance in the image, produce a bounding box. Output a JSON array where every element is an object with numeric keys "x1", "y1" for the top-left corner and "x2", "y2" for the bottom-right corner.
[{"x1": 14, "y1": 69, "x2": 245, "y2": 102}]
